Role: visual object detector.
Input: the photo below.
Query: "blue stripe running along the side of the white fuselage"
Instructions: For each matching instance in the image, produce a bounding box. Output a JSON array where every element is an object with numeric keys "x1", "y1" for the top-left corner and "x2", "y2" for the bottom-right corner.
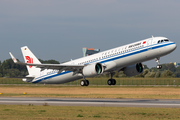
[{"x1": 32, "y1": 42, "x2": 175, "y2": 83}]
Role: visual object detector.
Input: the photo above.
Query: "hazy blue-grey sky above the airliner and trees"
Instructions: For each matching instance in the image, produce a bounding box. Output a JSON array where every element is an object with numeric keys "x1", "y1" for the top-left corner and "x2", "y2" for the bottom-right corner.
[{"x1": 0, "y1": 0, "x2": 180, "y2": 67}]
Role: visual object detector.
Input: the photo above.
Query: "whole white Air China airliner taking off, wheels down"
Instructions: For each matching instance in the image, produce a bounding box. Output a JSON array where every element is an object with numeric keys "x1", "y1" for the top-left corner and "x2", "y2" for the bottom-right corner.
[{"x1": 10, "y1": 36, "x2": 176, "y2": 86}]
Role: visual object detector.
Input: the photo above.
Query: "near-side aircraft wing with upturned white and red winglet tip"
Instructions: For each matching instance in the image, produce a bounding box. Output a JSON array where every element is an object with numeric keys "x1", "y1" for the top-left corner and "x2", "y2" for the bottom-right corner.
[{"x1": 9, "y1": 53, "x2": 84, "y2": 73}]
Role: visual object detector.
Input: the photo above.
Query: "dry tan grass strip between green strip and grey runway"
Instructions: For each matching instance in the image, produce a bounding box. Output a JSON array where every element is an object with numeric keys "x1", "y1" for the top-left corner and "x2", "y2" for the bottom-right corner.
[{"x1": 0, "y1": 85, "x2": 180, "y2": 99}]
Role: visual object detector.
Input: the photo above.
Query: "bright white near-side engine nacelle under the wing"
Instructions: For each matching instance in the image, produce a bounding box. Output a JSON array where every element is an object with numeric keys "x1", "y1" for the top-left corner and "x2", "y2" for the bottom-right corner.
[{"x1": 82, "y1": 63, "x2": 104, "y2": 77}]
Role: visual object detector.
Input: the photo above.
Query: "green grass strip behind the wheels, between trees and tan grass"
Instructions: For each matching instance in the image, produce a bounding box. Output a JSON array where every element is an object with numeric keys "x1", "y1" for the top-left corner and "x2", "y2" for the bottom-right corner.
[{"x1": 0, "y1": 78, "x2": 180, "y2": 86}]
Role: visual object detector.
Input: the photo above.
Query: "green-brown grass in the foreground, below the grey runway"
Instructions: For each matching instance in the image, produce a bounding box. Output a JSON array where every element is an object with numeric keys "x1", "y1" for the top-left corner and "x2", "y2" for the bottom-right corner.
[{"x1": 0, "y1": 105, "x2": 180, "y2": 120}]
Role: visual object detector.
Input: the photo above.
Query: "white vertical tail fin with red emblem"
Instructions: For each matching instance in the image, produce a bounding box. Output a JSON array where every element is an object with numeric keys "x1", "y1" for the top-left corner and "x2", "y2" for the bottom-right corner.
[{"x1": 21, "y1": 46, "x2": 41, "y2": 77}]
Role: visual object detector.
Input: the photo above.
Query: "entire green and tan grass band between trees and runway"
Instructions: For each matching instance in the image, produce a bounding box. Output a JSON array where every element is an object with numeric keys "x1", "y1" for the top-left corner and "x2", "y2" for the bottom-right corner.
[{"x1": 0, "y1": 78, "x2": 180, "y2": 99}]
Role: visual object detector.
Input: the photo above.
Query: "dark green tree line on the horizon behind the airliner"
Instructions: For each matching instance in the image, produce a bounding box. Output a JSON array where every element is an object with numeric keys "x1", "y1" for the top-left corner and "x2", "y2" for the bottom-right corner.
[{"x1": 0, "y1": 59, "x2": 180, "y2": 78}]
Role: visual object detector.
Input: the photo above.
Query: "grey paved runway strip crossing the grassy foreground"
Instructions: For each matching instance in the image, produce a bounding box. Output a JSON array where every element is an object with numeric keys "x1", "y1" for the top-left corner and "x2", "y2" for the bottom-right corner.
[{"x1": 0, "y1": 97, "x2": 180, "y2": 108}]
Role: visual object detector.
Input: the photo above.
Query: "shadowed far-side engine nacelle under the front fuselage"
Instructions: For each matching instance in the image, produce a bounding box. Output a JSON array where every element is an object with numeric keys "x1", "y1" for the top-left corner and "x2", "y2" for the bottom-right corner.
[{"x1": 124, "y1": 63, "x2": 144, "y2": 77}]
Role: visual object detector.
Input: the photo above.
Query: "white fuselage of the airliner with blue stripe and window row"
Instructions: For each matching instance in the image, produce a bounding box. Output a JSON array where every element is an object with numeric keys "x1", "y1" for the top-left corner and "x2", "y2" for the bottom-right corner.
[{"x1": 32, "y1": 37, "x2": 176, "y2": 84}]
